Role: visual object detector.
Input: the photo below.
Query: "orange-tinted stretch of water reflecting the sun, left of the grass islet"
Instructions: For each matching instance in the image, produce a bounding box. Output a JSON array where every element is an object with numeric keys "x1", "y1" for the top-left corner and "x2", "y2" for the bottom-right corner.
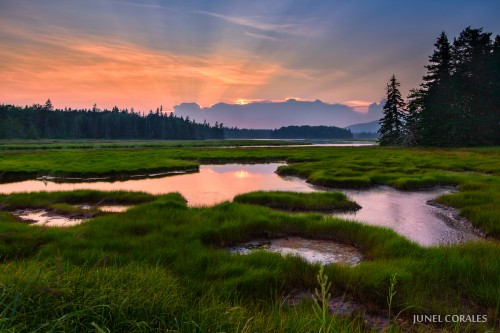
[{"x1": 0, "y1": 163, "x2": 314, "y2": 206}]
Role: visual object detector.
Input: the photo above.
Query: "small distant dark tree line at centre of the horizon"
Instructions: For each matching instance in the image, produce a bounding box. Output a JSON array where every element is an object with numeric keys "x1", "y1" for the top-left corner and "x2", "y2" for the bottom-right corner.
[{"x1": 224, "y1": 125, "x2": 353, "y2": 139}]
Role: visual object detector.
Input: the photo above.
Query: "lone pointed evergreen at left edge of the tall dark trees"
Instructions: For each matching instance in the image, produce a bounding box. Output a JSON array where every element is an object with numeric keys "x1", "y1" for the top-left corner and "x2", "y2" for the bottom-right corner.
[{"x1": 379, "y1": 75, "x2": 405, "y2": 146}]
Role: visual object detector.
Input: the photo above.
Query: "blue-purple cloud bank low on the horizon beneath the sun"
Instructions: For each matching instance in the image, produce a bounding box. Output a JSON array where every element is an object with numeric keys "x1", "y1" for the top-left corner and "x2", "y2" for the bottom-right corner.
[{"x1": 174, "y1": 99, "x2": 383, "y2": 129}]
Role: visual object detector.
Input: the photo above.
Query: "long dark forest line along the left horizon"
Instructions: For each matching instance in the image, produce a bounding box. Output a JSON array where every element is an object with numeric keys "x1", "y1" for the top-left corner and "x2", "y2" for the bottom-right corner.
[{"x1": 0, "y1": 99, "x2": 224, "y2": 140}]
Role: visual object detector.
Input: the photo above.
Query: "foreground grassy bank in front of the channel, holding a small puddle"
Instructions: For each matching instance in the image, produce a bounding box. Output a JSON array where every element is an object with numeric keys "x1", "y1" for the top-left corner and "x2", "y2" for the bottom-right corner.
[{"x1": 0, "y1": 194, "x2": 500, "y2": 332}]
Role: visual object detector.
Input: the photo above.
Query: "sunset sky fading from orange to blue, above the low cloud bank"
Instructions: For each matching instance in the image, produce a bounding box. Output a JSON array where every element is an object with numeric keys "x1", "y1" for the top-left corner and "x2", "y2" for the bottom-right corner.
[{"x1": 0, "y1": 0, "x2": 500, "y2": 112}]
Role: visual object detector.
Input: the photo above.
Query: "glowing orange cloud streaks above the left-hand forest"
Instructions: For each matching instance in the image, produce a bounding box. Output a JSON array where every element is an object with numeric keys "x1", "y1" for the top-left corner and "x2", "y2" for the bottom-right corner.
[{"x1": 0, "y1": 23, "x2": 296, "y2": 111}]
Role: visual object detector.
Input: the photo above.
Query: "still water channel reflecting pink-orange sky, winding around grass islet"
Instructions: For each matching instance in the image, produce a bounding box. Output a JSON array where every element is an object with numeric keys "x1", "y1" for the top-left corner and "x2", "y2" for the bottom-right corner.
[{"x1": 0, "y1": 163, "x2": 480, "y2": 245}]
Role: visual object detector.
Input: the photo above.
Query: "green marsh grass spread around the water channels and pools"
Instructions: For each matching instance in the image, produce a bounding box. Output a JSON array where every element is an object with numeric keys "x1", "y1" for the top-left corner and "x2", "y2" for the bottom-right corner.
[{"x1": 0, "y1": 147, "x2": 500, "y2": 332}]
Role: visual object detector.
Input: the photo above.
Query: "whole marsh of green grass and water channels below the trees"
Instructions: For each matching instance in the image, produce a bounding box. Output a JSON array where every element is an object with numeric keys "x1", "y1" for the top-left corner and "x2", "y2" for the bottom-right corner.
[{"x1": 0, "y1": 143, "x2": 500, "y2": 332}]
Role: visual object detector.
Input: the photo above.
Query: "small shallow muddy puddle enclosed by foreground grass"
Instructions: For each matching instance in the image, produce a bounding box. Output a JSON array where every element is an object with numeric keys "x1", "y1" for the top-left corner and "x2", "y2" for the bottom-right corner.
[{"x1": 229, "y1": 237, "x2": 363, "y2": 266}]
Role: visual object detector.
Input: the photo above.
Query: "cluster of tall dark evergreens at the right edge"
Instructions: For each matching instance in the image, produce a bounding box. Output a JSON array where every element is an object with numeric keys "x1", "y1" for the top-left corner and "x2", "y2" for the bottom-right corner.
[{"x1": 379, "y1": 27, "x2": 500, "y2": 147}]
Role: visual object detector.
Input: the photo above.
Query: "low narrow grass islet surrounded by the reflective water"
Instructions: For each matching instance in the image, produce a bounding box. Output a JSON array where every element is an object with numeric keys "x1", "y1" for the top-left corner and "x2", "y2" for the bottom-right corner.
[{"x1": 233, "y1": 191, "x2": 361, "y2": 212}]
